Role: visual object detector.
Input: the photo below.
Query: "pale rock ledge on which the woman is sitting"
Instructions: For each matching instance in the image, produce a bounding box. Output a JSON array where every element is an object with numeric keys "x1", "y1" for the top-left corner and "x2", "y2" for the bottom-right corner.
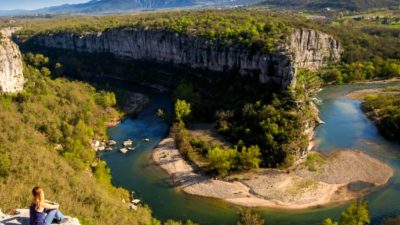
[{"x1": 0, "y1": 209, "x2": 81, "y2": 225}]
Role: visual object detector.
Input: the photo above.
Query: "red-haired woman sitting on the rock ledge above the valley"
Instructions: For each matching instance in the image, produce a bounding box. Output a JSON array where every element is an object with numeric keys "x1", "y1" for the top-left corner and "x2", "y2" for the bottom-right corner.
[{"x1": 29, "y1": 187, "x2": 68, "y2": 225}]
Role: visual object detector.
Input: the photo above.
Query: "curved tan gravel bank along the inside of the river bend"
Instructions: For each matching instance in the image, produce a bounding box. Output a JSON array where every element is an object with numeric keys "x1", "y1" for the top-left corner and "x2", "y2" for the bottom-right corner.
[{"x1": 153, "y1": 137, "x2": 393, "y2": 209}]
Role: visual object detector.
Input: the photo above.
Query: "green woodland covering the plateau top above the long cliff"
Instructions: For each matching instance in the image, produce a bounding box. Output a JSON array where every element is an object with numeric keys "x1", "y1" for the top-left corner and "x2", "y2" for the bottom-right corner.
[{"x1": 19, "y1": 10, "x2": 306, "y2": 52}]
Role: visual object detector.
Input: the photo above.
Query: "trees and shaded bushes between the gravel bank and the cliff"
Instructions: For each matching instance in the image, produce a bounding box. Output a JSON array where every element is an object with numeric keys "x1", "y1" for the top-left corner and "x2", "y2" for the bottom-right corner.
[{"x1": 169, "y1": 70, "x2": 321, "y2": 176}]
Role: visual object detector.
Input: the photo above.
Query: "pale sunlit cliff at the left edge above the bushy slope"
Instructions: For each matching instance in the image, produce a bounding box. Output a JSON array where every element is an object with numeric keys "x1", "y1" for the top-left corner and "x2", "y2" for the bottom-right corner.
[{"x1": 0, "y1": 29, "x2": 24, "y2": 93}]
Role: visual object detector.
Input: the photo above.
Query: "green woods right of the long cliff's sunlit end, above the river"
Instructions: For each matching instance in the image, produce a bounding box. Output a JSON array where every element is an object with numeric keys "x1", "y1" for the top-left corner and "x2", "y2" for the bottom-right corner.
[{"x1": 321, "y1": 13, "x2": 400, "y2": 84}]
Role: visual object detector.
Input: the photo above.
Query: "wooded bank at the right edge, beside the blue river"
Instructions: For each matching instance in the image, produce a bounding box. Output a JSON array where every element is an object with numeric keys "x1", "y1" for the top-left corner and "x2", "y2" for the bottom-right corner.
[{"x1": 362, "y1": 88, "x2": 400, "y2": 140}]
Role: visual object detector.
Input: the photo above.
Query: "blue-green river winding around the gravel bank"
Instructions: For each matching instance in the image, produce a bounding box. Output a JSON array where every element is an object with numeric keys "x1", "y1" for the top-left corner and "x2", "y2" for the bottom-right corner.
[{"x1": 102, "y1": 81, "x2": 400, "y2": 225}]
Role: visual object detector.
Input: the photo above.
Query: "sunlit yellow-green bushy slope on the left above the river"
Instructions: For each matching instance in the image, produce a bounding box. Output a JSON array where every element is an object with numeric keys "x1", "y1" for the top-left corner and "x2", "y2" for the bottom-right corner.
[{"x1": 0, "y1": 55, "x2": 155, "y2": 224}]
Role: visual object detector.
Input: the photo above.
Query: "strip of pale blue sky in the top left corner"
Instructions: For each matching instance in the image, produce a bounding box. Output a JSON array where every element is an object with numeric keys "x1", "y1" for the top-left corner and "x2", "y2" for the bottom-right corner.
[{"x1": 0, "y1": 0, "x2": 89, "y2": 10}]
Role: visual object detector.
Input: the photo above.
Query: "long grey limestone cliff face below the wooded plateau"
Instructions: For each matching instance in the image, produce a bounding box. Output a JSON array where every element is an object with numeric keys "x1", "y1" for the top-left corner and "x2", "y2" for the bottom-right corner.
[{"x1": 34, "y1": 28, "x2": 342, "y2": 87}]
